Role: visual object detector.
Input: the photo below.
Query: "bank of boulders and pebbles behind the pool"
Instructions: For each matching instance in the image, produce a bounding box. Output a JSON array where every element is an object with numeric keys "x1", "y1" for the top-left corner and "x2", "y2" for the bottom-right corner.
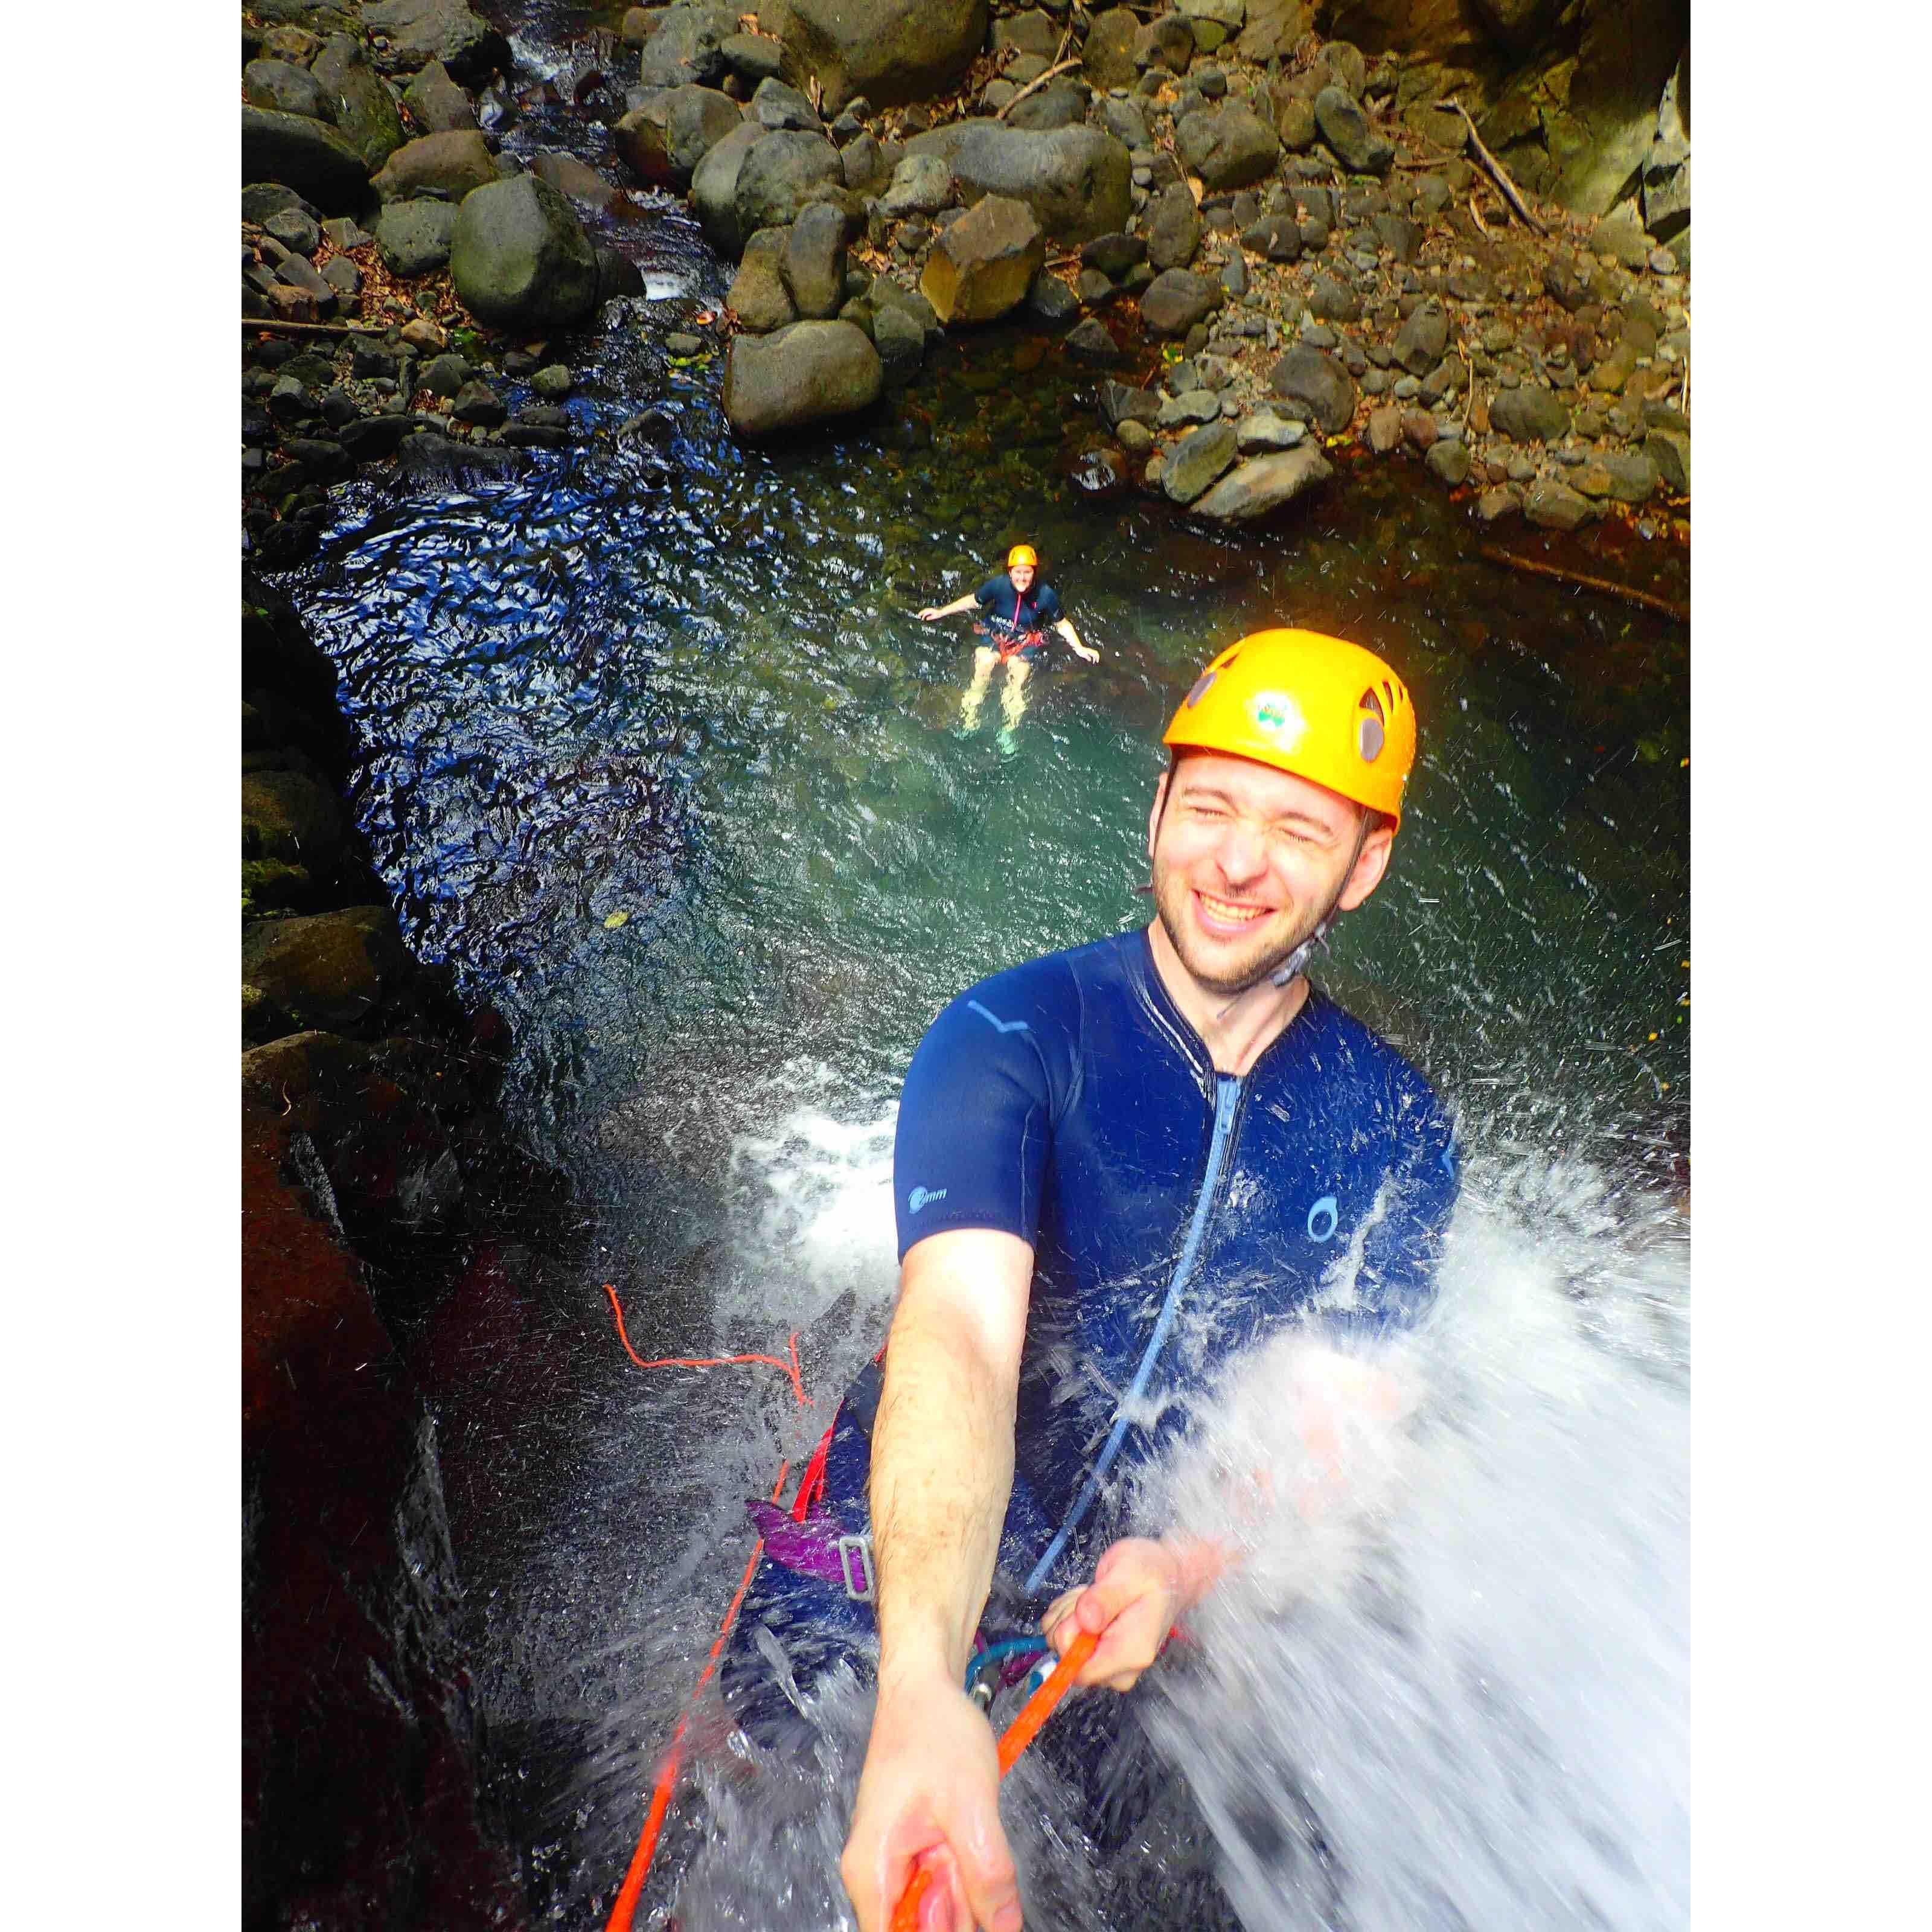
[{"x1": 243, "y1": 0, "x2": 1690, "y2": 560}]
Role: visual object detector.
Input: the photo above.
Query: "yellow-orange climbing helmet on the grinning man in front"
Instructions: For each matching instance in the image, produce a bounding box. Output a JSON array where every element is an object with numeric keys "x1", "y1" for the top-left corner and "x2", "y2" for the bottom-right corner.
[{"x1": 1163, "y1": 630, "x2": 1416, "y2": 825}]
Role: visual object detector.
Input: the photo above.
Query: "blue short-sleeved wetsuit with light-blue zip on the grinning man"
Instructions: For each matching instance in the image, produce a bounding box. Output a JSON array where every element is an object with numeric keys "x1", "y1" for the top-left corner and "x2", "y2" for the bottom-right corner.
[{"x1": 724, "y1": 931, "x2": 1457, "y2": 1746}]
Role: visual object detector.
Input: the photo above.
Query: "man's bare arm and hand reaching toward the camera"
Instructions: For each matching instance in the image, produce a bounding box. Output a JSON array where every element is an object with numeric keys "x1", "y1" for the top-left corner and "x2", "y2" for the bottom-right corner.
[{"x1": 839, "y1": 1229, "x2": 1034, "y2": 1932}]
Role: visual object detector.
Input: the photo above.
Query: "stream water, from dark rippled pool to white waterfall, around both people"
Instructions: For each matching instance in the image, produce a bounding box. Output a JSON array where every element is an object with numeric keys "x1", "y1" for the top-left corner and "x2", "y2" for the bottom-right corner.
[{"x1": 272, "y1": 18, "x2": 1690, "y2": 1932}]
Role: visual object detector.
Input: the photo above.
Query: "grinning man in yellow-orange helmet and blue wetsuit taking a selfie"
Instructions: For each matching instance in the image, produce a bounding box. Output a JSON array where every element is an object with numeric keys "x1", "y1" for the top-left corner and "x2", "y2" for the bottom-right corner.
[{"x1": 724, "y1": 630, "x2": 1457, "y2": 1932}]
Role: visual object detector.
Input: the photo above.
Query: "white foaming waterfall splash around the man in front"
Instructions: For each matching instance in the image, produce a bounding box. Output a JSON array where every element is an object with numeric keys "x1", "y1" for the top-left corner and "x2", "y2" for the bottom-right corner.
[{"x1": 630, "y1": 1113, "x2": 1689, "y2": 1932}]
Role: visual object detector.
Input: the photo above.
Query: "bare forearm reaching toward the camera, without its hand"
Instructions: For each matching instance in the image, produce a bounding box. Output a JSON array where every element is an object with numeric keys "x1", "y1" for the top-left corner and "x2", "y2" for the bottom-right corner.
[{"x1": 871, "y1": 1302, "x2": 1014, "y2": 1679}]
